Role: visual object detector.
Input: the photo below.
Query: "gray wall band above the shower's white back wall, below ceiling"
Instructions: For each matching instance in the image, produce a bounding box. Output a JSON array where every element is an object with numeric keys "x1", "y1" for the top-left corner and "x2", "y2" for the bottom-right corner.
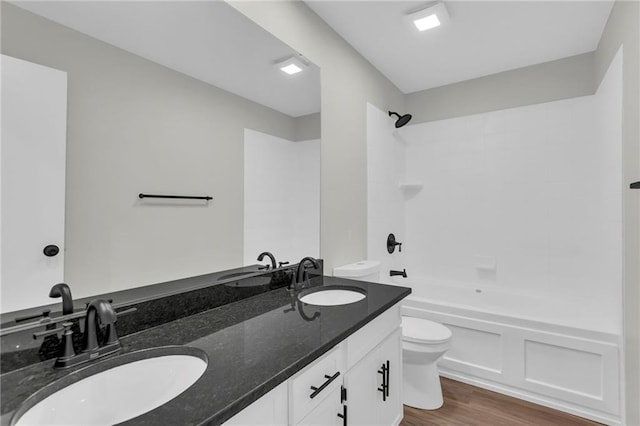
[{"x1": 407, "y1": 53, "x2": 595, "y2": 124}]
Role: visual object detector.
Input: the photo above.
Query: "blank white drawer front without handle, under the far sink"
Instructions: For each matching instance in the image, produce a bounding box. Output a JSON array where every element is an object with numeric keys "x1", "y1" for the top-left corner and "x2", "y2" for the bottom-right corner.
[{"x1": 345, "y1": 304, "x2": 401, "y2": 370}]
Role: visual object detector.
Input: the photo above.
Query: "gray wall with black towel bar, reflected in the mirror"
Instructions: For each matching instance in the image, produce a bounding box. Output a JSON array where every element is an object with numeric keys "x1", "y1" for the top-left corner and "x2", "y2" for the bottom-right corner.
[{"x1": 2, "y1": 2, "x2": 302, "y2": 296}]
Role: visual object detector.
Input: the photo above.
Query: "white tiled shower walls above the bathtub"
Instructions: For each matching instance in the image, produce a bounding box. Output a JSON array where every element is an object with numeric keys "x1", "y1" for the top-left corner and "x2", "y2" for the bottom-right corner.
[{"x1": 367, "y1": 52, "x2": 622, "y2": 331}]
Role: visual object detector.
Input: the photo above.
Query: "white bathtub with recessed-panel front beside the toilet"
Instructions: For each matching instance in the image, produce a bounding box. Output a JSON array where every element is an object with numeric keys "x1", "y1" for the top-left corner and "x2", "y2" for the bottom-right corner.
[{"x1": 397, "y1": 279, "x2": 622, "y2": 425}]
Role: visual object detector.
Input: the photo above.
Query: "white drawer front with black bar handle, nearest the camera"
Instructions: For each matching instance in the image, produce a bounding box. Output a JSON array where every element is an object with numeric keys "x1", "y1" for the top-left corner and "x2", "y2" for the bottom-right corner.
[{"x1": 289, "y1": 345, "x2": 345, "y2": 424}]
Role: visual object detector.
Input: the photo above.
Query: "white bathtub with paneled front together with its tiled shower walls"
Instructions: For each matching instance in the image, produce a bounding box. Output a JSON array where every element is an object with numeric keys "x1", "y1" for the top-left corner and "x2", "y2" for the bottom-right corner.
[{"x1": 368, "y1": 52, "x2": 624, "y2": 424}]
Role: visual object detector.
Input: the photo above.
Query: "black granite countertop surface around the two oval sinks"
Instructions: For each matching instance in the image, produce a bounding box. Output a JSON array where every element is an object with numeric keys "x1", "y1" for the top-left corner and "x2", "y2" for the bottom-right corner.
[{"x1": 0, "y1": 276, "x2": 411, "y2": 425}]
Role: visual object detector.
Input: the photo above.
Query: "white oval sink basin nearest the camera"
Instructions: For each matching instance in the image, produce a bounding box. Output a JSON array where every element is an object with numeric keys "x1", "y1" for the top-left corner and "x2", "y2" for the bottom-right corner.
[{"x1": 12, "y1": 347, "x2": 207, "y2": 425}]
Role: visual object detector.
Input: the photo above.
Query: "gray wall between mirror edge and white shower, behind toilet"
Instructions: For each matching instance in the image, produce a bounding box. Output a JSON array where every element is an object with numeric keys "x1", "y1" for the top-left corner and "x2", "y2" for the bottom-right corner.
[{"x1": 228, "y1": 1, "x2": 404, "y2": 271}]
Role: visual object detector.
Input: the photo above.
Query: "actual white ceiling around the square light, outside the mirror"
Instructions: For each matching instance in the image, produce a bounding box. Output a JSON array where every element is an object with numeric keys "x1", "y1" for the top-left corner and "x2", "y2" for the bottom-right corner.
[{"x1": 306, "y1": 0, "x2": 613, "y2": 93}]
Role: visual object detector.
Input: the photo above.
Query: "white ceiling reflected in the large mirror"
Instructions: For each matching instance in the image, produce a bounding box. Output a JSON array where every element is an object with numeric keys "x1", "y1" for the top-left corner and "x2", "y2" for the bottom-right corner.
[{"x1": 12, "y1": 1, "x2": 320, "y2": 117}]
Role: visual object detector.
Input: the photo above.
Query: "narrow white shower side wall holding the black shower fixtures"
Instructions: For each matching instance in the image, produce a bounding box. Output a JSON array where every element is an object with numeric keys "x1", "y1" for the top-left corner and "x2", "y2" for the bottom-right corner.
[{"x1": 367, "y1": 104, "x2": 408, "y2": 284}]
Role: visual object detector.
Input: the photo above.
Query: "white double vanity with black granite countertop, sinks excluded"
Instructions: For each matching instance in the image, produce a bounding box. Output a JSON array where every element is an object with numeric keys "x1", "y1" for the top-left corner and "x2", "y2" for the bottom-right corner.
[{"x1": 0, "y1": 271, "x2": 411, "y2": 425}]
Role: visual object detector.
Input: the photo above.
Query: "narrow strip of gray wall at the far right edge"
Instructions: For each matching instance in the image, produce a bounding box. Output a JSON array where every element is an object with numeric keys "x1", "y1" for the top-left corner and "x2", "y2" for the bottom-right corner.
[{"x1": 595, "y1": 0, "x2": 640, "y2": 425}]
